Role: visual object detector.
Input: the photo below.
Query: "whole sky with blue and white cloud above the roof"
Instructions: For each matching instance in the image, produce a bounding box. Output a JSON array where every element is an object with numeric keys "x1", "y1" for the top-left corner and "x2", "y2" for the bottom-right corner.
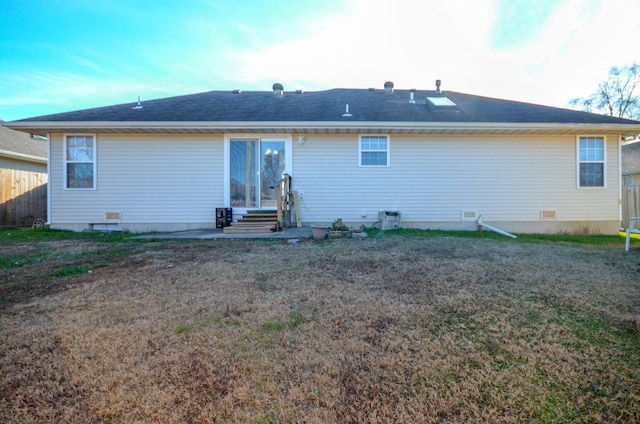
[{"x1": 0, "y1": 0, "x2": 640, "y2": 121}]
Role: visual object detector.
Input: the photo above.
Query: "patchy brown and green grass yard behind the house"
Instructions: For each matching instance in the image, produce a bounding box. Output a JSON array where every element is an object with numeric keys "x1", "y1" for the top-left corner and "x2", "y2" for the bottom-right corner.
[{"x1": 0, "y1": 230, "x2": 640, "y2": 424}]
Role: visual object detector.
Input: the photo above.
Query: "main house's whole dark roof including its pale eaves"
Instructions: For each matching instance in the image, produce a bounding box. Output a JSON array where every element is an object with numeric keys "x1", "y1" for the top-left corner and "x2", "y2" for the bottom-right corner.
[{"x1": 9, "y1": 89, "x2": 640, "y2": 134}]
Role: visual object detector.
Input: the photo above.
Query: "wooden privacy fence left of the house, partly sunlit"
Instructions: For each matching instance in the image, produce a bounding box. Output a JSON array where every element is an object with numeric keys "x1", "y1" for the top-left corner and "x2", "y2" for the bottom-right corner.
[{"x1": 0, "y1": 169, "x2": 47, "y2": 227}]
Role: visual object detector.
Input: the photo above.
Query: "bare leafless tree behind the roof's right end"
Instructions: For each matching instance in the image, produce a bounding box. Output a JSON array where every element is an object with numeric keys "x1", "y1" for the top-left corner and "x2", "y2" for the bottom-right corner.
[{"x1": 569, "y1": 63, "x2": 640, "y2": 120}]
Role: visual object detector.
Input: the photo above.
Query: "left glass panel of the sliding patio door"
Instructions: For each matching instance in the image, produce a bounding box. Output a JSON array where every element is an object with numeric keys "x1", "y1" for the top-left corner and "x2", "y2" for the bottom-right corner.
[{"x1": 230, "y1": 140, "x2": 259, "y2": 208}]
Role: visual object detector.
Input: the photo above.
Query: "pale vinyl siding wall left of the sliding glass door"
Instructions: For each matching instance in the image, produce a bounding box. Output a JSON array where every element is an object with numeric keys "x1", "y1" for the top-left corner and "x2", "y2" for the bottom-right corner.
[{"x1": 50, "y1": 134, "x2": 224, "y2": 229}]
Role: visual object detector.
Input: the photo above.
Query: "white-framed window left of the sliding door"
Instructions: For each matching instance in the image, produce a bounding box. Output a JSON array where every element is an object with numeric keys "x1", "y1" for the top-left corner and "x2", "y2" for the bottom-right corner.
[{"x1": 64, "y1": 135, "x2": 96, "y2": 189}]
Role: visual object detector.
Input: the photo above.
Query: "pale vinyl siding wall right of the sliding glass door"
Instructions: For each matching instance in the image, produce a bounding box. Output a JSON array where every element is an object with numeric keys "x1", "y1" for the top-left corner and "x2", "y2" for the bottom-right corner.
[{"x1": 293, "y1": 135, "x2": 619, "y2": 227}]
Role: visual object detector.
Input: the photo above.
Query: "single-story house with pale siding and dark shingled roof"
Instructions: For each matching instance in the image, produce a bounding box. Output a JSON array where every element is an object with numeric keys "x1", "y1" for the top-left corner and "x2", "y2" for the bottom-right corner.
[{"x1": 5, "y1": 81, "x2": 640, "y2": 234}]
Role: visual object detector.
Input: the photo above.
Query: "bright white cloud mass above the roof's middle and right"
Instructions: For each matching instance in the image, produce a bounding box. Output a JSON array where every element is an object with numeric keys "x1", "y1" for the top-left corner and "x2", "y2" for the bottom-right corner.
[{"x1": 226, "y1": 0, "x2": 640, "y2": 106}]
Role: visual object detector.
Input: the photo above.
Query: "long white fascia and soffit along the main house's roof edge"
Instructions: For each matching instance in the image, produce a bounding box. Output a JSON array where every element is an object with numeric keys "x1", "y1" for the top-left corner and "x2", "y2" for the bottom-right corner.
[{"x1": 4, "y1": 121, "x2": 640, "y2": 135}]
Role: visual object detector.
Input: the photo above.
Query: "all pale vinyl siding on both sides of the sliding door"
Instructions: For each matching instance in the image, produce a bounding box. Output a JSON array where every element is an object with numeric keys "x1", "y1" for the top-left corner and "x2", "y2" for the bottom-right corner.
[{"x1": 49, "y1": 134, "x2": 620, "y2": 232}]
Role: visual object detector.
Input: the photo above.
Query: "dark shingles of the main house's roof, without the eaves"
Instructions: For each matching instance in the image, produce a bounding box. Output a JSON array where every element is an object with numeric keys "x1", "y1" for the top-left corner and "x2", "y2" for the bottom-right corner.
[{"x1": 8, "y1": 89, "x2": 640, "y2": 125}]
